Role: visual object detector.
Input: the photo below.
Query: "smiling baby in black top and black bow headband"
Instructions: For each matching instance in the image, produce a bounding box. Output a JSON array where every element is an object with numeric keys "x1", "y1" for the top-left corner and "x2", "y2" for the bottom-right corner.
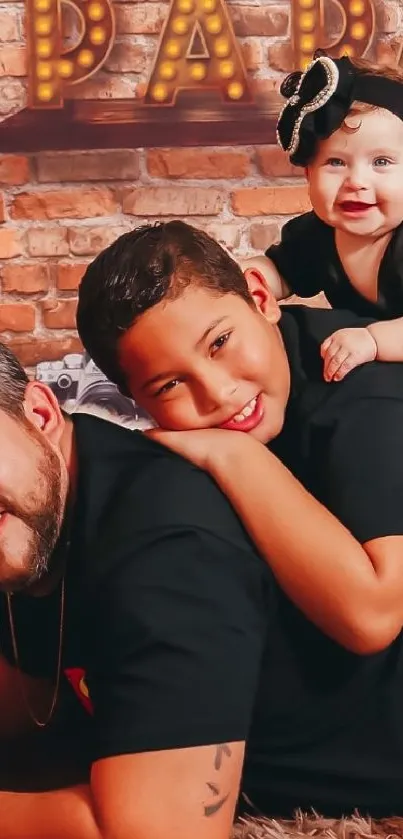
[{"x1": 241, "y1": 55, "x2": 403, "y2": 381}]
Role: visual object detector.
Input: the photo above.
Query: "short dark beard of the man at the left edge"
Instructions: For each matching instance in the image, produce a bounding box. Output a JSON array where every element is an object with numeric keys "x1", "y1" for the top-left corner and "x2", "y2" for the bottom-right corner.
[{"x1": 0, "y1": 429, "x2": 63, "y2": 592}]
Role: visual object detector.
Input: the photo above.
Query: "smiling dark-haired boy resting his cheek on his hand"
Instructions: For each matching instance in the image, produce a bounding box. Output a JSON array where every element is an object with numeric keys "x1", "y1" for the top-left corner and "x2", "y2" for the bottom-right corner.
[{"x1": 77, "y1": 221, "x2": 403, "y2": 652}]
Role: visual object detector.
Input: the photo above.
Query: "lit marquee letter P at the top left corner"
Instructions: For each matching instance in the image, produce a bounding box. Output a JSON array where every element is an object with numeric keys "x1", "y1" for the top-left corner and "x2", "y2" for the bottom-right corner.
[{"x1": 27, "y1": 0, "x2": 115, "y2": 108}]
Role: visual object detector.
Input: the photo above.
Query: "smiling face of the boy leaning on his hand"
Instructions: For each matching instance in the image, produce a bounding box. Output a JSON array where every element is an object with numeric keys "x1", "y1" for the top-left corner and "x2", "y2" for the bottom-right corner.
[{"x1": 119, "y1": 277, "x2": 290, "y2": 443}]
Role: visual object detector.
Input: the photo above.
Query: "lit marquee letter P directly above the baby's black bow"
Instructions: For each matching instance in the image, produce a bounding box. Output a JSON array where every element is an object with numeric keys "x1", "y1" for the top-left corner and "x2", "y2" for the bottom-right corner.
[{"x1": 292, "y1": 0, "x2": 375, "y2": 70}]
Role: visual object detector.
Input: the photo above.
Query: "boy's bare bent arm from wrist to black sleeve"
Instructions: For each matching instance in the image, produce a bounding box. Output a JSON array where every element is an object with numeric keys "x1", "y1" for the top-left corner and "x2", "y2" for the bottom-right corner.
[{"x1": 210, "y1": 434, "x2": 403, "y2": 654}]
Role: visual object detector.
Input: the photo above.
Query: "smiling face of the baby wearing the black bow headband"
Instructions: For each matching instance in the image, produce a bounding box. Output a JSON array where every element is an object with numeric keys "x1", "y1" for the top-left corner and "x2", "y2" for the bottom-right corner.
[{"x1": 307, "y1": 108, "x2": 403, "y2": 238}]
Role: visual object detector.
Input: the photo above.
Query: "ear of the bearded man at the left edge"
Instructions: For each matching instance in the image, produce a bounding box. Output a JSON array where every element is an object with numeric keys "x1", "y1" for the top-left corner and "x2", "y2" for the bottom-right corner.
[{"x1": 24, "y1": 381, "x2": 65, "y2": 445}]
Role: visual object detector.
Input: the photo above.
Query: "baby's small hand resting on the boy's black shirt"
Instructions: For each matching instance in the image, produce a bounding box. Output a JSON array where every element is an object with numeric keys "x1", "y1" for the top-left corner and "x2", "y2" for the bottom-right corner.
[{"x1": 320, "y1": 328, "x2": 378, "y2": 382}]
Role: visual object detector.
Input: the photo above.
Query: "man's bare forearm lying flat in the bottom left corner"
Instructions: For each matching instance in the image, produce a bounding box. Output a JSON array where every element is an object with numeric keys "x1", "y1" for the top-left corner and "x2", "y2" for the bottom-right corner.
[{"x1": 0, "y1": 785, "x2": 101, "y2": 839}]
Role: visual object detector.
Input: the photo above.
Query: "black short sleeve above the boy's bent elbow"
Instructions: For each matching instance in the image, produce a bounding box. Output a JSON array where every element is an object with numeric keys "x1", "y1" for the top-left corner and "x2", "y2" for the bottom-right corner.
[{"x1": 320, "y1": 397, "x2": 403, "y2": 544}]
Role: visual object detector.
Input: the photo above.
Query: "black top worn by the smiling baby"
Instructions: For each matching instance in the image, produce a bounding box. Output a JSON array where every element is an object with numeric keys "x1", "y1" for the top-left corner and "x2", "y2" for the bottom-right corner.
[{"x1": 266, "y1": 212, "x2": 403, "y2": 320}]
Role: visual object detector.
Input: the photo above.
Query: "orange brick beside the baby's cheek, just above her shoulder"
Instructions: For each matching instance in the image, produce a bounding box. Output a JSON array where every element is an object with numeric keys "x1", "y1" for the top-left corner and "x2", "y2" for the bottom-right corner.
[{"x1": 232, "y1": 185, "x2": 311, "y2": 216}]
